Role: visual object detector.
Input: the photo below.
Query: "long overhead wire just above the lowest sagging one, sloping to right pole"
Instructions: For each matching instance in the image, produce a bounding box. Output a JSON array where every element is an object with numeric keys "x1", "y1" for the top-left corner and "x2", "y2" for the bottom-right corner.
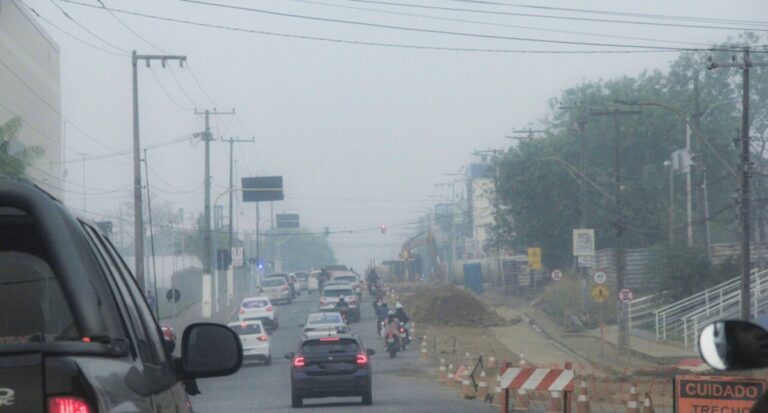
[{"x1": 181, "y1": 0, "x2": 732, "y2": 51}]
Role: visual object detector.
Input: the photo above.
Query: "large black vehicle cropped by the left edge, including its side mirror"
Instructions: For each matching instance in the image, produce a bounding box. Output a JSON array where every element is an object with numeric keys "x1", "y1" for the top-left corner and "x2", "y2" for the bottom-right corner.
[{"x1": 0, "y1": 180, "x2": 242, "y2": 413}]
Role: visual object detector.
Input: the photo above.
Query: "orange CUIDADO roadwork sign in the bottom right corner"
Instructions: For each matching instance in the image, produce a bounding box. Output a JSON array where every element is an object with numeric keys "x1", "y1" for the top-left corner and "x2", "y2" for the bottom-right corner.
[{"x1": 674, "y1": 375, "x2": 766, "y2": 412}]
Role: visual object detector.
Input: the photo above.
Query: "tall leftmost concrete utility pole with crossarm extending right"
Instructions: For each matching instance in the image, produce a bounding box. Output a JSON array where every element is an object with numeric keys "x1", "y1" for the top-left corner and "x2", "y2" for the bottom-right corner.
[{"x1": 131, "y1": 50, "x2": 187, "y2": 292}]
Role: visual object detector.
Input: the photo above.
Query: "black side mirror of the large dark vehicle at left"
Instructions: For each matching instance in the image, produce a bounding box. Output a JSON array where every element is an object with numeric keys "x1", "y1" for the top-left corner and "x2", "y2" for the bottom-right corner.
[{"x1": 180, "y1": 323, "x2": 243, "y2": 378}]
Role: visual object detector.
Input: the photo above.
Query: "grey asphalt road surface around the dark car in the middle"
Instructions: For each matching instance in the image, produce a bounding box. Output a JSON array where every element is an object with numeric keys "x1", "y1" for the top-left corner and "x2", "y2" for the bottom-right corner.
[{"x1": 191, "y1": 294, "x2": 486, "y2": 413}]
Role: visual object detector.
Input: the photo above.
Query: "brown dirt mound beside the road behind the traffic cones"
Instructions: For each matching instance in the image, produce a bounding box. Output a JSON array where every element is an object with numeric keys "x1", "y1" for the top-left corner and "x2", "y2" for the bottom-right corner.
[{"x1": 405, "y1": 286, "x2": 508, "y2": 327}]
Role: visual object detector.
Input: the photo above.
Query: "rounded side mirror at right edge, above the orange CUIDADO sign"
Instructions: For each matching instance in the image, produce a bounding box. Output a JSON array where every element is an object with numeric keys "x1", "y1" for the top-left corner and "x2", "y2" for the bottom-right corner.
[{"x1": 699, "y1": 320, "x2": 768, "y2": 370}]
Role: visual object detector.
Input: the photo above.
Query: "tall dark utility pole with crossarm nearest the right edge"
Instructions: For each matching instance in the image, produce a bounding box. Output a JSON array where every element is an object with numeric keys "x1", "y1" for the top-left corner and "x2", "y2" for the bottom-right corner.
[{"x1": 707, "y1": 47, "x2": 768, "y2": 320}]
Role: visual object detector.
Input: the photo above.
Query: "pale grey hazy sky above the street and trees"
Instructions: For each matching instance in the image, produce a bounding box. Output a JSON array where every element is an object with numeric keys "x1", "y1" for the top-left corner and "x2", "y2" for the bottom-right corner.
[{"x1": 21, "y1": 0, "x2": 768, "y2": 267}]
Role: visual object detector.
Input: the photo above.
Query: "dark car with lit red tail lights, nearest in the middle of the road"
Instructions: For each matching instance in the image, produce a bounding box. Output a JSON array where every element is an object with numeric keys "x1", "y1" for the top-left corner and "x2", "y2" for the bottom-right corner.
[{"x1": 285, "y1": 334, "x2": 374, "y2": 407}]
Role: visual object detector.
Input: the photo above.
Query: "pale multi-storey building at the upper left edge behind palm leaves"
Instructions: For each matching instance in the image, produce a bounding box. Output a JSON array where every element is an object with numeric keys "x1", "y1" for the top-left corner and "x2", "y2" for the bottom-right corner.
[{"x1": 0, "y1": 0, "x2": 64, "y2": 198}]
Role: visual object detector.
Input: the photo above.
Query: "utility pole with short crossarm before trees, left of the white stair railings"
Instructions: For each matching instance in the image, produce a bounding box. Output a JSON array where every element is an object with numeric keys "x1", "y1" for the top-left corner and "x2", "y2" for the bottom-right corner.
[{"x1": 590, "y1": 109, "x2": 641, "y2": 351}]
